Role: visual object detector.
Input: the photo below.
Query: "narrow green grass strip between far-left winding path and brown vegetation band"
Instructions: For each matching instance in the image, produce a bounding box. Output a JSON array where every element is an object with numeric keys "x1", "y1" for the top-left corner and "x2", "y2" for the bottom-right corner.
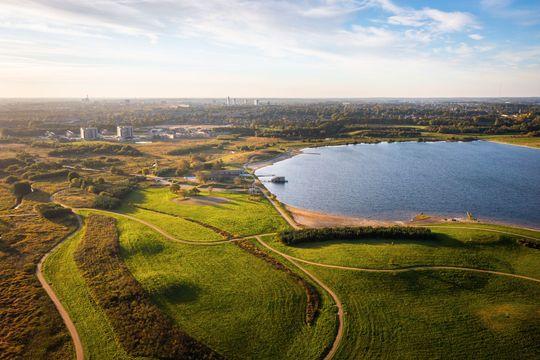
[{"x1": 43, "y1": 232, "x2": 131, "y2": 359}]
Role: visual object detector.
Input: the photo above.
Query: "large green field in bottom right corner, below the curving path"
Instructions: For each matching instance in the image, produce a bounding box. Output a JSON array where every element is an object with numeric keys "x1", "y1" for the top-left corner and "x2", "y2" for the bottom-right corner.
[{"x1": 306, "y1": 265, "x2": 540, "y2": 359}]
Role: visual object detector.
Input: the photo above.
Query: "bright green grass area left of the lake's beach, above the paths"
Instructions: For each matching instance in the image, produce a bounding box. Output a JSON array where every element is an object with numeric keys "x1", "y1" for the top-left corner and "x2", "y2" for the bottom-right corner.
[{"x1": 121, "y1": 188, "x2": 287, "y2": 236}]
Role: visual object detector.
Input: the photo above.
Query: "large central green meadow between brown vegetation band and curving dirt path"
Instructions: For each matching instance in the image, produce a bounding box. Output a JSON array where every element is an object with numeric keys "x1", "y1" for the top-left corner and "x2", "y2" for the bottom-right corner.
[{"x1": 118, "y1": 218, "x2": 336, "y2": 359}]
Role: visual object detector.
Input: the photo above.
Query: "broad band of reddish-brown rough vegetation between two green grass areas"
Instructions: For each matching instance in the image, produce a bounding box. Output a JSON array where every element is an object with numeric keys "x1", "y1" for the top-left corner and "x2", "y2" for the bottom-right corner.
[{"x1": 75, "y1": 215, "x2": 222, "y2": 359}]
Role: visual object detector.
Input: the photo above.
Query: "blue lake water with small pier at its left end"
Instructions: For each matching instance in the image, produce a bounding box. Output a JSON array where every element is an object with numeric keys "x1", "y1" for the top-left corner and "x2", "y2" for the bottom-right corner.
[{"x1": 256, "y1": 141, "x2": 540, "y2": 228}]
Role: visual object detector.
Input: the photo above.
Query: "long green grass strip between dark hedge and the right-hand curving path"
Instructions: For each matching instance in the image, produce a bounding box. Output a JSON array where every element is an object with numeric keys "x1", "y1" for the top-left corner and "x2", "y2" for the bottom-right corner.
[{"x1": 266, "y1": 224, "x2": 540, "y2": 278}]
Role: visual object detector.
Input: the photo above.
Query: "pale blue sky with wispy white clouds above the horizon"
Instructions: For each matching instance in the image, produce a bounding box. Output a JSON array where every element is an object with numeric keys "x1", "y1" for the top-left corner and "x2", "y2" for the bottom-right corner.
[{"x1": 0, "y1": 0, "x2": 540, "y2": 98}]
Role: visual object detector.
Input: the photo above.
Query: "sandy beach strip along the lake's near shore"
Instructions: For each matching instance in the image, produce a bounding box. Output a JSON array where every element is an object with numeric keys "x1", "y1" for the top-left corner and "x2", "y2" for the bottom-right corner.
[{"x1": 284, "y1": 204, "x2": 540, "y2": 231}]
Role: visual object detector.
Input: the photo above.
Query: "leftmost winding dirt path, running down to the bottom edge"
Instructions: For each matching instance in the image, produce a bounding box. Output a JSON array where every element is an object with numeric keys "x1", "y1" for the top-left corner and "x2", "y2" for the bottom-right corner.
[{"x1": 36, "y1": 216, "x2": 84, "y2": 360}]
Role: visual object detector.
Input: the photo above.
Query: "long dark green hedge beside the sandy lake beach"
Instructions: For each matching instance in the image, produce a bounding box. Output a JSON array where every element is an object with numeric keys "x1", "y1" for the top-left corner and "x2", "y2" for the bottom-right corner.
[{"x1": 279, "y1": 226, "x2": 434, "y2": 245}]
